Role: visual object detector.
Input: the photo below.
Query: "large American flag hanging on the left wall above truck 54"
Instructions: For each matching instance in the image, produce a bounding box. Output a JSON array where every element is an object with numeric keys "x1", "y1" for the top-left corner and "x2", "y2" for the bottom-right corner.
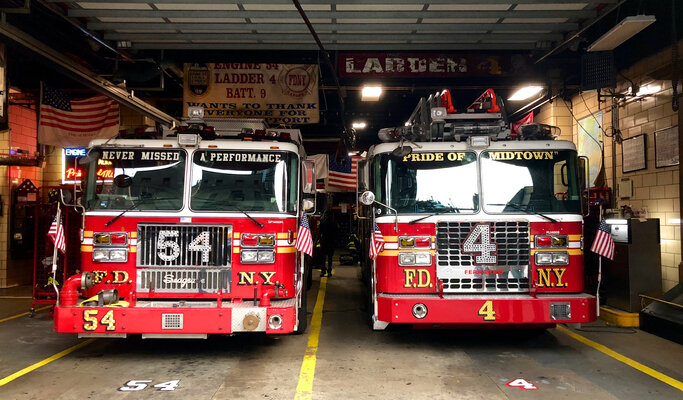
[{"x1": 38, "y1": 85, "x2": 119, "y2": 147}]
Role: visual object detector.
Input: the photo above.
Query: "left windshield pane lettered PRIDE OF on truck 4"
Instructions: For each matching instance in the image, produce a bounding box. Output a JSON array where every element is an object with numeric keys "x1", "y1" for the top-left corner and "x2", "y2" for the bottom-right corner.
[{"x1": 373, "y1": 152, "x2": 479, "y2": 214}]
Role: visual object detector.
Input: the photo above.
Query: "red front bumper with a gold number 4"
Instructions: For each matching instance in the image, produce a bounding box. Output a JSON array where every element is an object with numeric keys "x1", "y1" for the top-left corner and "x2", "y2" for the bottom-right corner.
[{"x1": 377, "y1": 293, "x2": 597, "y2": 325}]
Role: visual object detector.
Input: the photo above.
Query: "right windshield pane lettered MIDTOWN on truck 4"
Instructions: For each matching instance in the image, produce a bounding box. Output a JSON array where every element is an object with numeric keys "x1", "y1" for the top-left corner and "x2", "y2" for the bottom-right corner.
[{"x1": 480, "y1": 150, "x2": 581, "y2": 213}]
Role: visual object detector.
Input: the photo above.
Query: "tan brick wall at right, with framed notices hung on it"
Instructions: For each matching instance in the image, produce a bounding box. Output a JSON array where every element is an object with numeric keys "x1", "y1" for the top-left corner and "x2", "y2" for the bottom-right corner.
[{"x1": 536, "y1": 41, "x2": 683, "y2": 291}]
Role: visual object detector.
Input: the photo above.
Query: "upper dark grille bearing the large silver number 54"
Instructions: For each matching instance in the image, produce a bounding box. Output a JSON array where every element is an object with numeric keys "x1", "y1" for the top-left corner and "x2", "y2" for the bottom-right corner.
[{"x1": 137, "y1": 224, "x2": 232, "y2": 267}]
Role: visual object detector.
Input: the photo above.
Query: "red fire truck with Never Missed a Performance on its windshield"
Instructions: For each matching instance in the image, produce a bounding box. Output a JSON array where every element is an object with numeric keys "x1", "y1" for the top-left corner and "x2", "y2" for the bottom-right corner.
[{"x1": 54, "y1": 108, "x2": 315, "y2": 338}]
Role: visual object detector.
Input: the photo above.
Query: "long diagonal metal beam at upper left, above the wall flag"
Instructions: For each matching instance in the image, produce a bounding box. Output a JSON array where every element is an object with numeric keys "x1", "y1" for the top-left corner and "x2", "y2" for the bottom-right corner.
[{"x1": 0, "y1": 23, "x2": 177, "y2": 126}]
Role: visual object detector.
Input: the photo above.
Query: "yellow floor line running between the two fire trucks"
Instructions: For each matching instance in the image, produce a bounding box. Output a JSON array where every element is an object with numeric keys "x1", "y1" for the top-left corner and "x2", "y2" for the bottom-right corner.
[{"x1": 294, "y1": 277, "x2": 327, "y2": 400}]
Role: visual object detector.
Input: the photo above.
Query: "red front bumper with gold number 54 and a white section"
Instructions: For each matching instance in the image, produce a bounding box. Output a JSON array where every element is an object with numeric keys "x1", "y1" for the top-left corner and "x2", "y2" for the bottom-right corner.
[{"x1": 54, "y1": 299, "x2": 297, "y2": 338}]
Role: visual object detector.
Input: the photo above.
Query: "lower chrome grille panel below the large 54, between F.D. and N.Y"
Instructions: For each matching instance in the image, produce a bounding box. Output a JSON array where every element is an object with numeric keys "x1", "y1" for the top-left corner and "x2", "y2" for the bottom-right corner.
[{"x1": 137, "y1": 268, "x2": 231, "y2": 296}]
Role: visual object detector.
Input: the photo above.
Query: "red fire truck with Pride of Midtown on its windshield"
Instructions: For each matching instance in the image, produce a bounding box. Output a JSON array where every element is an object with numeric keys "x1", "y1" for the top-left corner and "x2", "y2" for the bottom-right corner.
[{"x1": 359, "y1": 89, "x2": 596, "y2": 330}]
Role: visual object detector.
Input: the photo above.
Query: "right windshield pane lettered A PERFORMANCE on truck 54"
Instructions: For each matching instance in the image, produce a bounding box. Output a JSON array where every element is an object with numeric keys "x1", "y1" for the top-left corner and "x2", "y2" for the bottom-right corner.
[{"x1": 190, "y1": 150, "x2": 298, "y2": 212}]
